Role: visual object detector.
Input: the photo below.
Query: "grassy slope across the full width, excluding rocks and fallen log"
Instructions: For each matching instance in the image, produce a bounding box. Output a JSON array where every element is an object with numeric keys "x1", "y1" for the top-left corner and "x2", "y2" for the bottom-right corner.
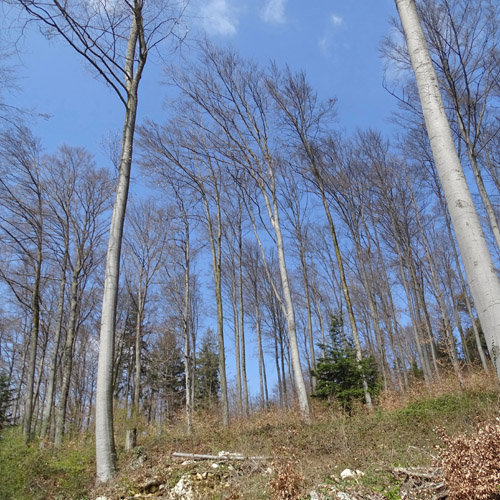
[{"x1": 0, "y1": 373, "x2": 500, "y2": 500}]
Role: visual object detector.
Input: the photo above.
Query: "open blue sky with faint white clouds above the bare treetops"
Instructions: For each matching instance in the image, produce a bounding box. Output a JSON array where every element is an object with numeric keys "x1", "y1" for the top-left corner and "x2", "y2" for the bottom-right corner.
[{"x1": 9, "y1": 0, "x2": 396, "y2": 168}]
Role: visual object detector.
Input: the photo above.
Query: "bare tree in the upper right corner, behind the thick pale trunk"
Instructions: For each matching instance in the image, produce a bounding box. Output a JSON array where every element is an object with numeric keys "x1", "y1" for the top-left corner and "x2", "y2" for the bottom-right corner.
[{"x1": 417, "y1": 0, "x2": 500, "y2": 254}]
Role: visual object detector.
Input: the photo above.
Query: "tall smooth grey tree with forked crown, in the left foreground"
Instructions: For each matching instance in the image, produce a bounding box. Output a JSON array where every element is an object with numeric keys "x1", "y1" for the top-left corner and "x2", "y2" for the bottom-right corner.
[{"x1": 12, "y1": 0, "x2": 187, "y2": 482}]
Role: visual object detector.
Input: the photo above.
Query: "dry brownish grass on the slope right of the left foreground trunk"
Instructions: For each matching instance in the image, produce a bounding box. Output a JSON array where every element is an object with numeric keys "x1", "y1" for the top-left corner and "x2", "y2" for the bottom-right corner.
[{"x1": 90, "y1": 373, "x2": 500, "y2": 500}]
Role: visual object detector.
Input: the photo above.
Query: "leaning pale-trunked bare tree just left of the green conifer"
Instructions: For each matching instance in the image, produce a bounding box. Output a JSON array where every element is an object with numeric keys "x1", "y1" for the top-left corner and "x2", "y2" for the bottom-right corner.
[{"x1": 180, "y1": 45, "x2": 310, "y2": 421}]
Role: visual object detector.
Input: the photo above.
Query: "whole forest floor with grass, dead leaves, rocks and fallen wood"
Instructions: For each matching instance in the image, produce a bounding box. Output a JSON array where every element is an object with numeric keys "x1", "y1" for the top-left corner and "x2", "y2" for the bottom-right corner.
[{"x1": 0, "y1": 372, "x2": 500, "y2": 500}]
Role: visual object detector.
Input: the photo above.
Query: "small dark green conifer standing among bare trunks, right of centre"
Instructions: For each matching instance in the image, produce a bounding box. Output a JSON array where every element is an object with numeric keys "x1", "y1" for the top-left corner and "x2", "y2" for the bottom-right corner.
[{"x1": 312, "y1": 315, "x2": 380, "y2": 411}]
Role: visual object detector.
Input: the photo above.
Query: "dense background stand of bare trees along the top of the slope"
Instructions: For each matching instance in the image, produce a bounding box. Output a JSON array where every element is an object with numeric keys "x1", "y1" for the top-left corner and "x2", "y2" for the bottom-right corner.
[{"x1": 0, "y1": 0, "x2": 500, "y2": 480}]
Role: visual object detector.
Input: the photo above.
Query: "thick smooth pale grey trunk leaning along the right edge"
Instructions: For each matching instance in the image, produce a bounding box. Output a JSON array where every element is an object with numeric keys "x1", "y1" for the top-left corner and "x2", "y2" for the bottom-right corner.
[{"x1": 396, "y1": 0, "x2": 500, "y2": 377}]
